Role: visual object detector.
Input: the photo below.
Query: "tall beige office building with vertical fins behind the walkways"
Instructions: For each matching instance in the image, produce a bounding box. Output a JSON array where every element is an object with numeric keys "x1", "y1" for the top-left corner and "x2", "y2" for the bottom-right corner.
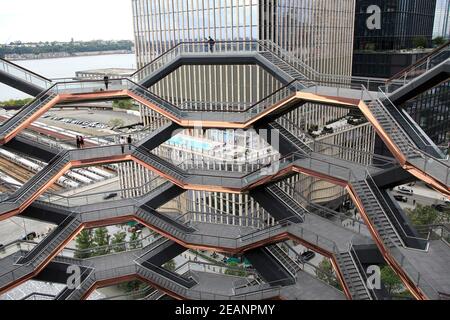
[{"x1": 126, "y1": 0, "x2": 374, "y2": 215}]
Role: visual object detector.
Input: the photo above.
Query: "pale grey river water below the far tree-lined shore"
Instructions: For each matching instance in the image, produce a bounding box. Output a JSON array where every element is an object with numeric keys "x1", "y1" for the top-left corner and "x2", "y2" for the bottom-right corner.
[{"x1": 0, "y1": 54, "x2": 136, "y2": 101}]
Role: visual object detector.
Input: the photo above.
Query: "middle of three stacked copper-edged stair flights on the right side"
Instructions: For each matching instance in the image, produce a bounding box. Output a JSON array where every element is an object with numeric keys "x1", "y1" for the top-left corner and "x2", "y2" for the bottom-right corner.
[{"x1": 352, "y1": 180, "x2": 403, "y2": 248}]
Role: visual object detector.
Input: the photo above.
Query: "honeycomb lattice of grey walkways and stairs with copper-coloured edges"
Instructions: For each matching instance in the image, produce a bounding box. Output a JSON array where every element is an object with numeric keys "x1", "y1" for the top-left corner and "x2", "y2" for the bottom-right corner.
[{"x1": 0, "y1": 7, "x2": 450, "y2": 300}]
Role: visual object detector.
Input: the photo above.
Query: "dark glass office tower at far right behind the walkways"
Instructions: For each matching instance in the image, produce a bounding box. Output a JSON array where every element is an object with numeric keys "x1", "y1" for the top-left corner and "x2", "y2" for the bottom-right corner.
[{"x1": 353, "y1": 0, "x2": 450, "y2": 145}]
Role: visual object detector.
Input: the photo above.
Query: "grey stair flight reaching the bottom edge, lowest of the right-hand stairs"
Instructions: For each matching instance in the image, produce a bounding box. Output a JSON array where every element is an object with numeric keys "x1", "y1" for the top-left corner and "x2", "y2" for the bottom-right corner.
[{"x1": 336, "y1": 252, "x2": 372, "y2": 300}]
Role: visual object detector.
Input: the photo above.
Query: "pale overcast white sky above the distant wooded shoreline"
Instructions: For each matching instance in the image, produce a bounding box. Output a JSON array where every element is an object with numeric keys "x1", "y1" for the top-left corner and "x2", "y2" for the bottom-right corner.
[{"x1": 0, "y1": 0, "x2": 134, "y2": 44}]
